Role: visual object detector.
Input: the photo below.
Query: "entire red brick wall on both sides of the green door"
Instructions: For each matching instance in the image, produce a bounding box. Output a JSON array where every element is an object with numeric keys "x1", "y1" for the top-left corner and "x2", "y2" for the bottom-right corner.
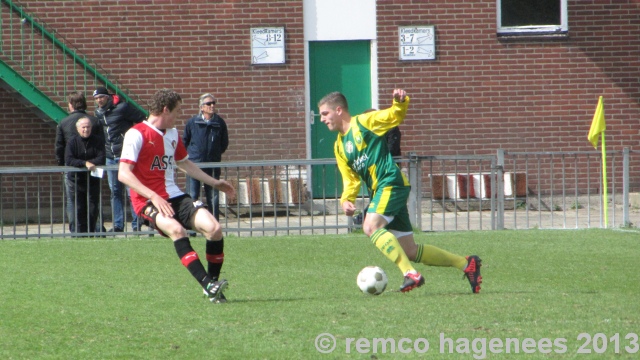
[{"x1": 0, "y1": 0, "x2": 640, "y2": 187}]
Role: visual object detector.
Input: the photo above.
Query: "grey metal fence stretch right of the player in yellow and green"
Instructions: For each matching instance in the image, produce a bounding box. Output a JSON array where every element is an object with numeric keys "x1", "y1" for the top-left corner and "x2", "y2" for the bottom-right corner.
[{"x1": 420, "y1": 149, "x2": 640, "y2": 231}]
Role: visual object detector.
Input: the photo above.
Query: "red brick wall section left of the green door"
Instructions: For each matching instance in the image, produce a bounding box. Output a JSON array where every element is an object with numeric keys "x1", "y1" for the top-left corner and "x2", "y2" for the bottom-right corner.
[{"x1": 0, "y1": 1, "x2": 305, "y2": 165}]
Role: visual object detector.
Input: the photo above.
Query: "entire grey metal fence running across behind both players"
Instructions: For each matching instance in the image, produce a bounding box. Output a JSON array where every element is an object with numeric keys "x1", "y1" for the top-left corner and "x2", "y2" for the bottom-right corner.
[{"x1": 0, "y1": 149, "x2": 640, "y2": 239}]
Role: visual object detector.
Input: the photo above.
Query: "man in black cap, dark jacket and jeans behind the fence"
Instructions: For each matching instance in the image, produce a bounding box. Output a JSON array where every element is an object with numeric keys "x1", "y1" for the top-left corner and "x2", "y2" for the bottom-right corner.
[{"x1": 93, "y1": 87, "x2": 145, "y2": 232}]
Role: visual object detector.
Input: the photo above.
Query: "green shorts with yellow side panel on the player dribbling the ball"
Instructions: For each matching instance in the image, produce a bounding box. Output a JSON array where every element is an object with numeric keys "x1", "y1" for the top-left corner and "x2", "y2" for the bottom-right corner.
[{"x1": 367, "y1": 186, "x2": 413, "y2": 232}]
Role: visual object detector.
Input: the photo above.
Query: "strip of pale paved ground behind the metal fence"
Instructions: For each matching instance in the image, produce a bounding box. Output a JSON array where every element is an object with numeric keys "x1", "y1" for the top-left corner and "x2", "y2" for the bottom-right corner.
[{"x1": 0, "y1": 203, "x2": 640, "y2": 239}]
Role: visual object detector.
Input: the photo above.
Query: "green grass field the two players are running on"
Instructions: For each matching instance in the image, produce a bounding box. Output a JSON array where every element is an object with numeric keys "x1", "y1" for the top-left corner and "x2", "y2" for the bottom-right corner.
[{"x1": 0, "y1": 229, "x2": 640, "y2": 359}]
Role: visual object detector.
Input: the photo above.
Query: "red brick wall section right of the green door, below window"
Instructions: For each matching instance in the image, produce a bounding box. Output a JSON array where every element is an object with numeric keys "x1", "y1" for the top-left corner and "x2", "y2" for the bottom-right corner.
[{"x1": 378, "y1": 0, "x2": 640, "y2": 154}]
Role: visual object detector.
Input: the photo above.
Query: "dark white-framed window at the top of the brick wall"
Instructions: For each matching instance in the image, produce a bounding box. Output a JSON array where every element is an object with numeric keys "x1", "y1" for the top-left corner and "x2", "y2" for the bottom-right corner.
[{"x1": 496, "y1": 0, "x2": 569, "y2": 35}]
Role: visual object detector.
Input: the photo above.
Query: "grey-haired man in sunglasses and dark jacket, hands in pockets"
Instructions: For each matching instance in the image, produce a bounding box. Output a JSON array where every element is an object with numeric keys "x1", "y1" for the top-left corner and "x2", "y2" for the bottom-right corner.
[{"x1": 183, "y1": 93, "x2": 229, "y2": 221}]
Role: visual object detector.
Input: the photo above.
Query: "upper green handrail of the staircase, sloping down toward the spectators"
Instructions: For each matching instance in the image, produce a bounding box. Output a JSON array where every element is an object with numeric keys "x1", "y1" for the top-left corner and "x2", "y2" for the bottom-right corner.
[{"x1": 0, "y1": 0, "x2": 149, "y2": 115}]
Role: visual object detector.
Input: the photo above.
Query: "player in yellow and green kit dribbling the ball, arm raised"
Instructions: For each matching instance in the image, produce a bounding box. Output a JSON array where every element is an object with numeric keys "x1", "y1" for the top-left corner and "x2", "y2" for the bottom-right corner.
[{"x1": 318, "y1": 89, "x2": 482, "y2": 293}]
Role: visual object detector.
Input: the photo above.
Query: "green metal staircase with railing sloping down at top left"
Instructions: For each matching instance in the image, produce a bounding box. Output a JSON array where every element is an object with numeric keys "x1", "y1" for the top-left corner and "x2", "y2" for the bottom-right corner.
[{"x1": 0, "y1": 0, "x2": 148, "y2": 123}]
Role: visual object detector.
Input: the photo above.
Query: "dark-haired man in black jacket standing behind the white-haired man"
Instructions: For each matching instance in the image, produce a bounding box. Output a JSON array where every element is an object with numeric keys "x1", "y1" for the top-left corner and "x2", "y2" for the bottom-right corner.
[{"x1": 55, "y1": 91, "x2": 104, "y2": 232}]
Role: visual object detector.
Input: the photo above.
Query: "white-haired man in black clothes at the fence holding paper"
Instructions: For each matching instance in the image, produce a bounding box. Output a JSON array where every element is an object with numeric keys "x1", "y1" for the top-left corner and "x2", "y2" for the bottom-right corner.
[{"x1": 65, "y1": 116, "x2": 105, "y2": 233}]
